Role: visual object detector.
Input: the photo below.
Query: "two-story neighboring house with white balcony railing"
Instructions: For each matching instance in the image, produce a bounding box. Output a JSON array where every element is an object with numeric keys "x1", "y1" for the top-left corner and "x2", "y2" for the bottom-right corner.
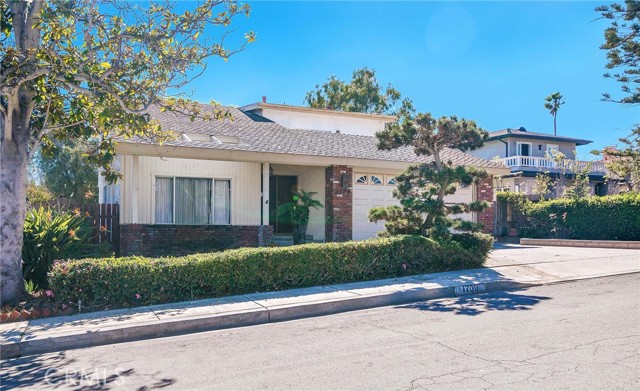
[{"x1": 470, "y1": 127, "x2": 607, "y2": 195}]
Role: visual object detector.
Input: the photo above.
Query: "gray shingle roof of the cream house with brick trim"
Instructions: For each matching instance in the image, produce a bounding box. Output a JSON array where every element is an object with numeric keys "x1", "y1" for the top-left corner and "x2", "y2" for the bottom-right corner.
[{"x1": 118, "y1": 105, "x2": 504, "y2": 168}]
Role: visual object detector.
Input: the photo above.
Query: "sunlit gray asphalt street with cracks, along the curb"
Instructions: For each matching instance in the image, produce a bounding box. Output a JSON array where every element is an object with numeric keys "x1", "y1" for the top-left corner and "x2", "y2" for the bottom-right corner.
[{"x1": 1, "y1": 274, "x2": 640, "y2": 390}]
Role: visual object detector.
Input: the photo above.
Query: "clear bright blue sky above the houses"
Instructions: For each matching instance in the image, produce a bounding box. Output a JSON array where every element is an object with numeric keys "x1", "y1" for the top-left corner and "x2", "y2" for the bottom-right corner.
[{"x1": 190, "y1": 1, "x2": 640, "y2": 158}]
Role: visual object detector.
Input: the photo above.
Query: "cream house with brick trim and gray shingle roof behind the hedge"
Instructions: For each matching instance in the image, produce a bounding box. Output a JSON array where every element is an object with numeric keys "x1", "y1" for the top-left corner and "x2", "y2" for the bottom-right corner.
[{"x1": 100, "y1": 102, "x2": 509, "y2": 255}]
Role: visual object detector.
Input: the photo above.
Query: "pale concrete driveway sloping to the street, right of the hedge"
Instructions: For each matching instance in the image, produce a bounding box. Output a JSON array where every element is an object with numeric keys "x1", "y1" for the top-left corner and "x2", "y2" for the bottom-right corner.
[{"x1": 486, "y1": 243, "x2": 640, "y2": 281}]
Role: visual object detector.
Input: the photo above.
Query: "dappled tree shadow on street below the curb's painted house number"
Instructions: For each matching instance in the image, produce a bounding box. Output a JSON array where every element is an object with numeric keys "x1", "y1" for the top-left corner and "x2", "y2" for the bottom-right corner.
[{"x1": 396, "y1": 292, "x2": 551, "y2": 316}]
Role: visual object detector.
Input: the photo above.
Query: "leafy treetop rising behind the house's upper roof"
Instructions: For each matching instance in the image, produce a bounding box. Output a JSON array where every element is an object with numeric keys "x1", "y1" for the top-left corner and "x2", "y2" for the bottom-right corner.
[{"x1": 305, "y1": 67, "x2": 414, "y2": 118}]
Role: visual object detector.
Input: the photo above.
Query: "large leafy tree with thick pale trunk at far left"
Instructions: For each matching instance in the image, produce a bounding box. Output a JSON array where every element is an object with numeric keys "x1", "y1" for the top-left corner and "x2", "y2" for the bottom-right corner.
[{"x1": 0, "y1": 0, "x2": 254, "y2": 302}]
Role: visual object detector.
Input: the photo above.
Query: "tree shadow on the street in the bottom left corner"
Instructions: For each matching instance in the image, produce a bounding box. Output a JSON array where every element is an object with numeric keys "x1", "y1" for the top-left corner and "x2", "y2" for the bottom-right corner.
[{"x1": 0, "y1": 352, "x2": 176, "y2": 391}]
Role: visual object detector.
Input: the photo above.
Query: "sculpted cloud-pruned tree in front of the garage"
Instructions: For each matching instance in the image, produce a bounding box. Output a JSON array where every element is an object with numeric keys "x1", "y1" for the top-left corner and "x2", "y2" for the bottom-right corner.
[{"x1": 369, "y1": 113, "x2": 489, "y2": 238}]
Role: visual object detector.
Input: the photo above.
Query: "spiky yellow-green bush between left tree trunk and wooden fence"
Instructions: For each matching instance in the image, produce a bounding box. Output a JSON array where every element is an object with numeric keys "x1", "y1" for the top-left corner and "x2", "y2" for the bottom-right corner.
[{"x1": 22, "y1": 207, "x2": 107, "y2": 289}]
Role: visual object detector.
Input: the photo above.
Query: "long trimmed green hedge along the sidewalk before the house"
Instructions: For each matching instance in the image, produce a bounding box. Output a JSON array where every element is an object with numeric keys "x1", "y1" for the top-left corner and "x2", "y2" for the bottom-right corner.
[{"x1": 49, "y1": 234, "x2": 493, "y2": 307}]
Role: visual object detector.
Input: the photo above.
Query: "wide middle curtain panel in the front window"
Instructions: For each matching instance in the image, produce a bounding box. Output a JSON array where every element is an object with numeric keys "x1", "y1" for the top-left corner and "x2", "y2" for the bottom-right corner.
[{"x1": 175, "y1": 178, "x2": 211, "y2": 224}]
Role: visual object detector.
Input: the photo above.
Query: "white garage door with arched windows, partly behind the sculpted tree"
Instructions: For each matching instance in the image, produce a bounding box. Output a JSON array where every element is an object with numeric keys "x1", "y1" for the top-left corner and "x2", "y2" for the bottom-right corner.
[{"x1": 353, "y1": 173, "x2": 473, "y2": 240}]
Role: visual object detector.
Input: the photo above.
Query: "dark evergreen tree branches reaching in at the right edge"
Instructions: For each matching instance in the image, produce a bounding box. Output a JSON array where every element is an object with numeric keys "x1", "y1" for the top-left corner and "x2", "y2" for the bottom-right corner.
[{"x1": 596, "y1": 0, "x2": 640, "y2": 191}]
